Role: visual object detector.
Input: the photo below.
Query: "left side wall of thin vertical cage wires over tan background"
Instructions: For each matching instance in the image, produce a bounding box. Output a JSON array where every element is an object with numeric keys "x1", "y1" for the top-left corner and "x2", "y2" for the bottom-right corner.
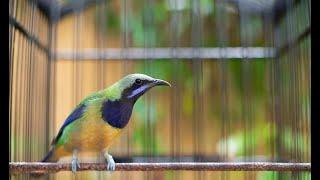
[{"x1": 9, "y1": 1, "x2": 50, "y2": 166}]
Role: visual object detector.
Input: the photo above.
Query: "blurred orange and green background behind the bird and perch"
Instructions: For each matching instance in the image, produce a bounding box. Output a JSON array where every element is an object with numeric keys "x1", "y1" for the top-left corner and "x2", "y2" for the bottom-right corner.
[{"x1": 9, "y1": 0, "x2": 311, "y2": 180}]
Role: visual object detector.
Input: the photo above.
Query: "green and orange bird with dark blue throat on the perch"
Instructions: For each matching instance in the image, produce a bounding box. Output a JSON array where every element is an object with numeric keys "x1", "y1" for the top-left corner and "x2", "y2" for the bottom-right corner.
[{"x1": 42, "y1": 74, "x2": 171, "y2": 172}]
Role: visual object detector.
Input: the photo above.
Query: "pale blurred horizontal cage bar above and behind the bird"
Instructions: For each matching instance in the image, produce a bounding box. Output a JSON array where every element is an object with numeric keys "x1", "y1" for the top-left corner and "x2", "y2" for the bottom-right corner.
[{"x1": 56, "y1": 47, "x2": 274, "y2": 60}]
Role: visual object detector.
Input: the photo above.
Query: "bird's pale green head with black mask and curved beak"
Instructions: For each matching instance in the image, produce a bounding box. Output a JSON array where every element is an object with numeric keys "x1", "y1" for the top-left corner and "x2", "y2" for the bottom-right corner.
[{"x1": 109, "y1": 74, "x2": 171, "y2": 102}]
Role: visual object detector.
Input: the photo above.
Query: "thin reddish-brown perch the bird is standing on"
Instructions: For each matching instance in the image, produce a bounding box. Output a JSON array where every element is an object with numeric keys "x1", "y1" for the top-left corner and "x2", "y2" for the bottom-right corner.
[{"x1": 9, "y1": 162, "x2": 311, "y2": 174}]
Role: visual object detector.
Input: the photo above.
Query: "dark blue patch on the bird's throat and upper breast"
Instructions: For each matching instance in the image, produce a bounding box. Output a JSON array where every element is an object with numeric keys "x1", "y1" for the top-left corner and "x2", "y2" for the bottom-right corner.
[{"x1": 101, "y1": 100, "x2": 134, "y2": 128}]
